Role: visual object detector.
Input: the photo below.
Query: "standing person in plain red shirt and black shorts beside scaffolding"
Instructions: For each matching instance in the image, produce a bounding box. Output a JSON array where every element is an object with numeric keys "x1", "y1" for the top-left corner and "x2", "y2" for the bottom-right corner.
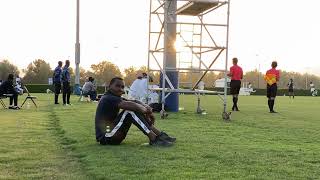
[{"x1": 228, "y1": 58, "x2": 243, "y2": 111}]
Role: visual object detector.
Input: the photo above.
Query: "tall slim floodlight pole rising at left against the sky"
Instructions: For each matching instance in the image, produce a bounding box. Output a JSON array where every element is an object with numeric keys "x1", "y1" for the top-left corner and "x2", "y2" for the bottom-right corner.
[{"x1": 74, "y1": 0, "x2": 80, "y2": 95}]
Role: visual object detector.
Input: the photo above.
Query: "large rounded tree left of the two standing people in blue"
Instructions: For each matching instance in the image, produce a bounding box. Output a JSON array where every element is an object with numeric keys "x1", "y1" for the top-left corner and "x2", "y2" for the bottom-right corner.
[{"x1": 23, "y1": 59, "x2": 53, "y2": 84}]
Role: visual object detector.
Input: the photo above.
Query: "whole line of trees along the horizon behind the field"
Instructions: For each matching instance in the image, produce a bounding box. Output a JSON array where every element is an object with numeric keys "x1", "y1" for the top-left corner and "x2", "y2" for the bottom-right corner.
[{"x1": 0, "y1": 59, "x2": 320, "y2": 89}]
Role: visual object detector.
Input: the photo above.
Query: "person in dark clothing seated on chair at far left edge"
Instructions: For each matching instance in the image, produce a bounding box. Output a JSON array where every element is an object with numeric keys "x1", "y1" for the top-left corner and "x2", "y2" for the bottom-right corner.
[{"x1": 0, "y1": 74, "x2": 20, "y2": 109}]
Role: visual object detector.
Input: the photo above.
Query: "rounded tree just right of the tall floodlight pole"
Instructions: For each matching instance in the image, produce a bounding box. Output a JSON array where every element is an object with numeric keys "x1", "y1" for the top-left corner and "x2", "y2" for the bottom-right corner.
[{"x1": 91, "y1": 61, "x2": 122, "y2": 85}]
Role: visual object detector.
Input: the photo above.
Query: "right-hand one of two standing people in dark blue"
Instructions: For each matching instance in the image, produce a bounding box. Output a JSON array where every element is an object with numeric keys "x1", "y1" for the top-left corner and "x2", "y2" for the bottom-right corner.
[{"x1": 62, "y1": 60, "x2": 71, "y2": 105}]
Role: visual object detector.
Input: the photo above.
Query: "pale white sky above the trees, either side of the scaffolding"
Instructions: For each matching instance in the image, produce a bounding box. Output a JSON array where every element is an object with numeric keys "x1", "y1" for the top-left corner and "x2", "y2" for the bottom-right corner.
[{"x1": 0, "y1": 0, "x2": 320, "y2": 75}]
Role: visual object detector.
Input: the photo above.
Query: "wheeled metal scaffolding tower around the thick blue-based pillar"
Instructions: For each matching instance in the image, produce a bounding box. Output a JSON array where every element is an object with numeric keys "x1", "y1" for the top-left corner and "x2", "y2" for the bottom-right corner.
[{"x1": 148, "y1": 0, "x2": 230, "y2": 120}]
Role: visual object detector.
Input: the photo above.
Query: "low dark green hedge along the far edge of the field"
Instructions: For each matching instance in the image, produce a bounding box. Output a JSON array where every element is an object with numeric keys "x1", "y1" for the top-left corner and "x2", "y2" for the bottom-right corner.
[{"x1": 26, "y1": 84, "x2": 311, "y2": 96}]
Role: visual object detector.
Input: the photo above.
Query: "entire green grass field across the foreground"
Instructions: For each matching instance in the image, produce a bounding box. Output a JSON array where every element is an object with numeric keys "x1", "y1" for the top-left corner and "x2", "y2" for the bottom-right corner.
[{"x1": 0, "y1": 94, "x2": 320, "y2": 179}]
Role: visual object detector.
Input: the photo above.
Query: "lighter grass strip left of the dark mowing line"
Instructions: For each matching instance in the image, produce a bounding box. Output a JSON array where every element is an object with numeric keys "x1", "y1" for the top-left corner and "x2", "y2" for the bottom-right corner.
[{"x1": 0, "y1": 94, "x2": 87, "y2": 179}]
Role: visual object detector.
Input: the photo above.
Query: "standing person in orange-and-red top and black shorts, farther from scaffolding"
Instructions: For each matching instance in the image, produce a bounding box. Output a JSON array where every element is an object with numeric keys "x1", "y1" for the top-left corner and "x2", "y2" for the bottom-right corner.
[{"x1": 264, "y1": 61, "x2": 280, "y2": 113}]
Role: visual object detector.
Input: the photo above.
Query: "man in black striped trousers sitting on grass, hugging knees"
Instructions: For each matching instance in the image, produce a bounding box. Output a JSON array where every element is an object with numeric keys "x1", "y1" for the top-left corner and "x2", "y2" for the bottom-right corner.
[{"x1": 95, "y1": 77, "x2": 176, "y2": 146}]
